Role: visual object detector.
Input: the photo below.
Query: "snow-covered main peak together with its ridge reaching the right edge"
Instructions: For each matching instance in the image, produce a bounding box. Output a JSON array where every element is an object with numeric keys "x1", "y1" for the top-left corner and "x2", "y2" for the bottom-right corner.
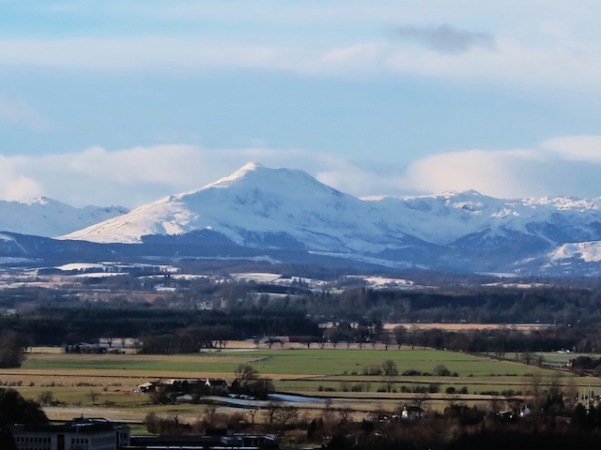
[{"x1": 57, "y1": 163, "x2": 601, "y2": 270}]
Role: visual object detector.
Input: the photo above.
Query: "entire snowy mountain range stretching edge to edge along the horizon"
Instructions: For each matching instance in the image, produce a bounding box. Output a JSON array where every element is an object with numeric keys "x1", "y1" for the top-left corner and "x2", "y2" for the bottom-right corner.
[{"x1": 0, "y1": 163, "x2": 601, "y2": 276}]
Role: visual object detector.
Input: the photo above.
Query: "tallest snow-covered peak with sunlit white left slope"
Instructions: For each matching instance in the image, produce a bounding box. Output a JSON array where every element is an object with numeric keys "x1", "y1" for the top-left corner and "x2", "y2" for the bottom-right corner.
[{"x1": 62, "y1": 163, "x2": 418, "y2": 252}]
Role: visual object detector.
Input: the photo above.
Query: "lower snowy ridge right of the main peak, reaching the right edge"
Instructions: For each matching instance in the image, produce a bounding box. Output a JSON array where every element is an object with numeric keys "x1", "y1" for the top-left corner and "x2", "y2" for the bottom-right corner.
[{"x1": 367, "y1": 191, "x2": 601, "y2": 245}]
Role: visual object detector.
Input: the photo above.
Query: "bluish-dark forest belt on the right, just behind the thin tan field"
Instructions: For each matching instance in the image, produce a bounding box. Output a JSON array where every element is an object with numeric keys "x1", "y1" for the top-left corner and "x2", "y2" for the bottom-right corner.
[{"x1": 302, "y1": 287, "x2": 601, "y2": 324}]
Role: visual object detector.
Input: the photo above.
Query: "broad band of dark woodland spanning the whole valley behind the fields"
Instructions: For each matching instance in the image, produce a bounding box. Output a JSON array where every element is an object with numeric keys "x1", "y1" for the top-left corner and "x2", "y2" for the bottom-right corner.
[{"x1": 0, "y1": 277, "x2": 601, "y2": 356}]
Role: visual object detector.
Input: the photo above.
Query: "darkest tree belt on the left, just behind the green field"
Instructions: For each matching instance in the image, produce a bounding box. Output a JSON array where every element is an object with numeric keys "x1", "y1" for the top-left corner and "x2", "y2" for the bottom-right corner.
[{"x1": 0, "y1": 305, "x2": 320, "y2": 353}]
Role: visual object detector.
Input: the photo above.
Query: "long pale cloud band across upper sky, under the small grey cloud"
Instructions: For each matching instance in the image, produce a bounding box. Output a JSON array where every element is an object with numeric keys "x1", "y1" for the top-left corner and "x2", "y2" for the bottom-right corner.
[{"x1": 0, "y1": 27, "x2": 601, "y2": 94}]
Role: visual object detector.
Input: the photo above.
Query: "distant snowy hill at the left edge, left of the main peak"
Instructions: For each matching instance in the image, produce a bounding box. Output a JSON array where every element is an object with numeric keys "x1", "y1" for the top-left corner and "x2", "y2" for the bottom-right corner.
[{"x1": 0, "y1": 197, "x2": 127, "y2": 237}]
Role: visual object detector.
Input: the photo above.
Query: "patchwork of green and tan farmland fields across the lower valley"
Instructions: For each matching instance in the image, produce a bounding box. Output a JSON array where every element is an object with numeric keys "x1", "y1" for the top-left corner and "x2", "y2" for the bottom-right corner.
[{"x1": 0, "y1": 348, "x2": 601, "y2": 421}]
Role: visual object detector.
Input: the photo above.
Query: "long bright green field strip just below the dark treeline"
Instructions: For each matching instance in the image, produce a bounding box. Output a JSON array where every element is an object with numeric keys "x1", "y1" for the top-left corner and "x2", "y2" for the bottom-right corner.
[{"x1": 22, "y1": 349, "x2": 556, "y2": 378}]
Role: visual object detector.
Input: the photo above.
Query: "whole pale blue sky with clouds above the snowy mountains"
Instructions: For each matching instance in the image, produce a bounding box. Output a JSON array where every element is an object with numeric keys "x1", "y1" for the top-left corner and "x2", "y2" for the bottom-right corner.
[{"x1": 0, "y1": 0, "x2": 601, "y2": 207}]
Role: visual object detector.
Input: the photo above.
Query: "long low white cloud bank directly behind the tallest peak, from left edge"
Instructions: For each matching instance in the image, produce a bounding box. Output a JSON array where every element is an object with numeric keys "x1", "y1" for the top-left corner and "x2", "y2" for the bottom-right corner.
[{"x1": 0, "y1": 145, "x2": 404, "y2": 207}]
